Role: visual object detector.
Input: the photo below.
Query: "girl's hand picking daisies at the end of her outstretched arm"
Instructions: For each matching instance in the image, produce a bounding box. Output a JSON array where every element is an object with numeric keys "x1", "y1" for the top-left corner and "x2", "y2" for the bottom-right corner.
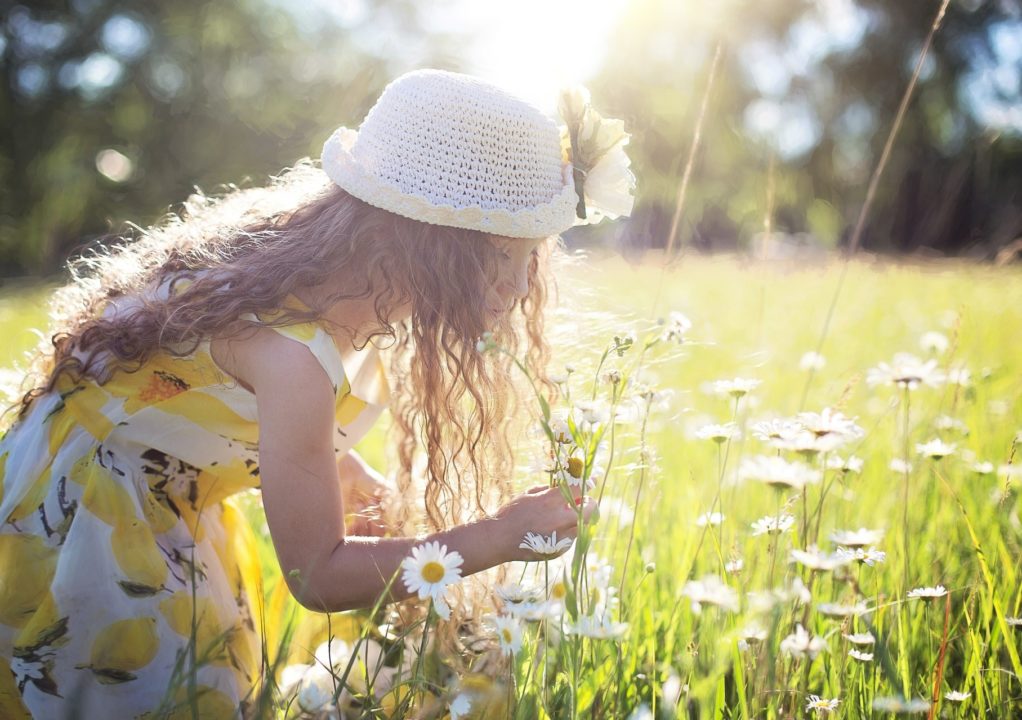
[{"x1": 494, "y1": 485, "x2": 599, "y2": 562}]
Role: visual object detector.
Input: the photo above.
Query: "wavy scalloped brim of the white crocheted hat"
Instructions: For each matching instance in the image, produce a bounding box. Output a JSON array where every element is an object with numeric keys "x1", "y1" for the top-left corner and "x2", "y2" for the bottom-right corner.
[{"x1": 321, "y1": 127, "x2": 578, "y2": 238}]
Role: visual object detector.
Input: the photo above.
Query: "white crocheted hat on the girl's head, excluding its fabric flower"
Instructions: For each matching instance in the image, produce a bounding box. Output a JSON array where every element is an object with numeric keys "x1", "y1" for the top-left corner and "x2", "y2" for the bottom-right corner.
[{"x1": 322, "y1": 69, "x2": 578, "y2": 238}]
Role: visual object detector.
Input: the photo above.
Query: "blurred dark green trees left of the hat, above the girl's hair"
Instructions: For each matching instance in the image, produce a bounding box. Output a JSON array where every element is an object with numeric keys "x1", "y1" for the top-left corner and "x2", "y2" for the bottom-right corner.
[{"x1": 0, "y1": 0, "x2": 468, "y2": 277}]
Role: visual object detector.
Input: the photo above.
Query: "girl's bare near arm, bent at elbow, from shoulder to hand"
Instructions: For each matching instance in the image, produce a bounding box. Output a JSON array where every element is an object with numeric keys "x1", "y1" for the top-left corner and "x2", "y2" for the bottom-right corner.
[{"x1": 223, "y1": 330, "x2": 595, "y2": 612}]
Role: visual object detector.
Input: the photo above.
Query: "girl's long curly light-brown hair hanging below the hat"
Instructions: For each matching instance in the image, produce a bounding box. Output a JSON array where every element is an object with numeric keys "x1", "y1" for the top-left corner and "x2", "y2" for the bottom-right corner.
[{"x1": 12, "y1": 161, "x2": 558, "y2": 532}]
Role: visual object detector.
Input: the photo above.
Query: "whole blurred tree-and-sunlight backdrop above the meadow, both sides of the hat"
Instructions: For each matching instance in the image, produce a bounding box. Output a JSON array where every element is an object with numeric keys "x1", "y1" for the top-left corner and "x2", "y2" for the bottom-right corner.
[{"x1": 0, "y1": 0, "x2": 1022, "y2": 278}]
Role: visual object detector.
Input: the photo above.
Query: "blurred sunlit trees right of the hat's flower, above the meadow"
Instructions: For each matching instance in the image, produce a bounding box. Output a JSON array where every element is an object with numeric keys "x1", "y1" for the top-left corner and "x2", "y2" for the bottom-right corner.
[{"x1": 592, "y1": 0, "x2": 1022, "y2": 257}]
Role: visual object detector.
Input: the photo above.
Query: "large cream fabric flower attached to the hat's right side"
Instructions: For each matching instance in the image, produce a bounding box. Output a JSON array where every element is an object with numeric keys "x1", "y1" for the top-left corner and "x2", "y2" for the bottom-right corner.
[{"x1": 557, "y1": 85, "x2": 636, "y2": 225}]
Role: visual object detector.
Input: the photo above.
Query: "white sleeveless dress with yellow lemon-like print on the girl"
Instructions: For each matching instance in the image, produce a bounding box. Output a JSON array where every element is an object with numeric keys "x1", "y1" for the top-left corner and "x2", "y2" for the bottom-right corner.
[{"x1": 0, "y1": 290, "x2": 389, "y2": 719}]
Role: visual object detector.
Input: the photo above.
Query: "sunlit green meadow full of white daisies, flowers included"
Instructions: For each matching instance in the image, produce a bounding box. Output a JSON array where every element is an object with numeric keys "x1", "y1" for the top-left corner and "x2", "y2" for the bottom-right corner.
[{"x1": 0, "y1": 255, "x2": 1022, "y2": 719}]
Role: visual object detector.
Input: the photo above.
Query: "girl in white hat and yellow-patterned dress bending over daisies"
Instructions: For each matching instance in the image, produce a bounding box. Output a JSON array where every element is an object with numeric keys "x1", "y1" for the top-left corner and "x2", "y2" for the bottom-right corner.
[{"x1": 0, "y1": 65, "x2": 625, "y2": 718}]
